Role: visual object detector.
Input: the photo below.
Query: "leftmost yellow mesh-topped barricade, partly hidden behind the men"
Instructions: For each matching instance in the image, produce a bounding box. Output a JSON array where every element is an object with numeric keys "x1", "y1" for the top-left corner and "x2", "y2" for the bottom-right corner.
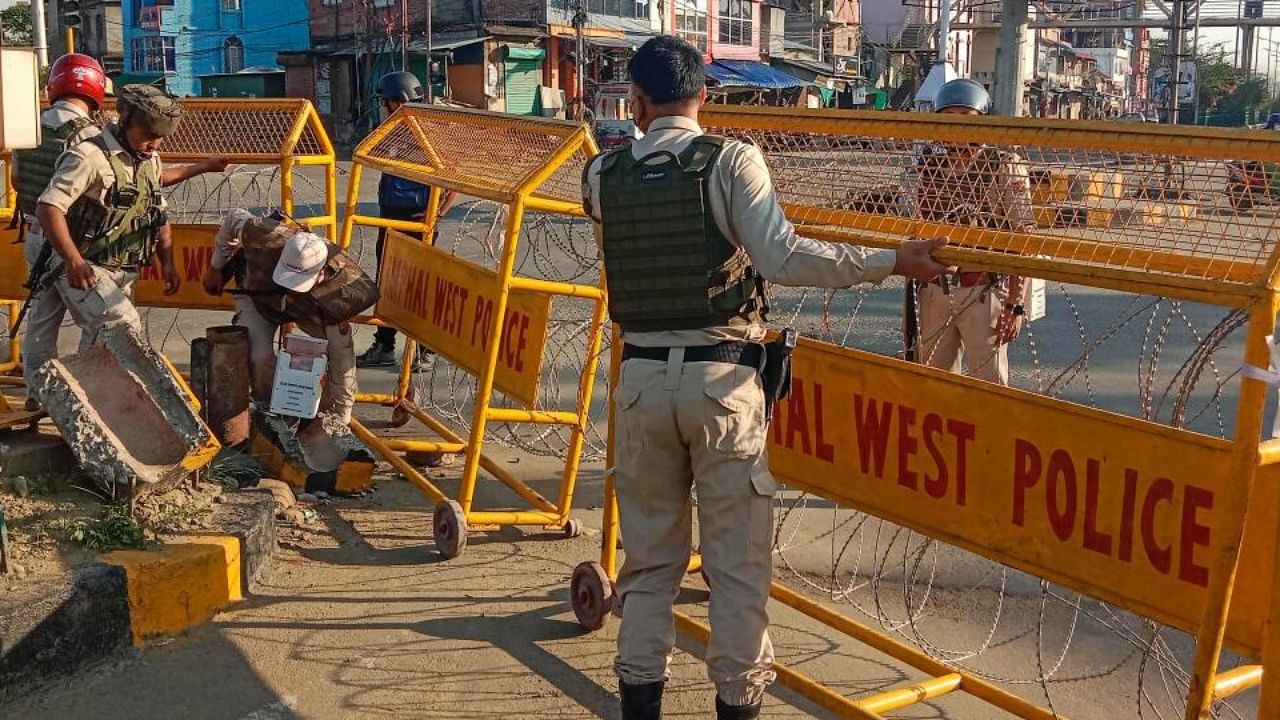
[{"x1": 0, "y1": 97, "x2": 338, "y2": 381}]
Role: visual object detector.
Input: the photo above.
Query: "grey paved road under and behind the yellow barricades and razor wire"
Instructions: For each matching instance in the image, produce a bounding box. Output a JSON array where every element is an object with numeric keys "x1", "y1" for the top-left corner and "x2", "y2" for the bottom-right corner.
[{"x1": 4, "y1": 159, "x2": 1251, "y2": 720}]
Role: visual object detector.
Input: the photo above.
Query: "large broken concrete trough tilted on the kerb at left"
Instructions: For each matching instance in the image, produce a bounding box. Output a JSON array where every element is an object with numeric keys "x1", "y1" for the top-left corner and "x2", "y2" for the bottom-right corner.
[{"x1": 33, "y1": 327, "x2": 219, "y2": 495}]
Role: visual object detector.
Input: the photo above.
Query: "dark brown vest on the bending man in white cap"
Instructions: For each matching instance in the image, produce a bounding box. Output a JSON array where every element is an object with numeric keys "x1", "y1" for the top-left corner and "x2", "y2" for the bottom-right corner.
[{"x1": 236, "y1": 218, "x2": 379, "y2": 325}]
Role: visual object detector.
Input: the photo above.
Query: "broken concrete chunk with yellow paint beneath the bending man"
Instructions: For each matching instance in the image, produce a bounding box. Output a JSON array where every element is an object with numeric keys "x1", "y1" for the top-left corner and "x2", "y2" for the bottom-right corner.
[{"x1": 252, "y1": 413, "x2": 378, "y2": 495}]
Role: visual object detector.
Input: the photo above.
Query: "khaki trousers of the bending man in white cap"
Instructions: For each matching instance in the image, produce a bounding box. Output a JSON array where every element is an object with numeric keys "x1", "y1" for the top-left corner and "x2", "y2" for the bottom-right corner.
[{"x1": 232, "y1": 295, "x2": 356, "y2": 425}]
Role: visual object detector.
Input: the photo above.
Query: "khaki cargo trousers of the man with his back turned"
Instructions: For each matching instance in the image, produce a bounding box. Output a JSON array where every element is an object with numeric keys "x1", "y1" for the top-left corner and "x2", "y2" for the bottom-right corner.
[{"x1": 614, "y1": 348, "x2": 777, "y2": 705}]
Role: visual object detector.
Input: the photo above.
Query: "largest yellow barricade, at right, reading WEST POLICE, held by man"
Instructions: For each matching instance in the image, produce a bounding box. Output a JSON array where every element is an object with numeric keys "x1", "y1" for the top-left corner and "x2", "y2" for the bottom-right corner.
[{"x1": 571, "y1": 106, "x2": 1280, "y2": 720}]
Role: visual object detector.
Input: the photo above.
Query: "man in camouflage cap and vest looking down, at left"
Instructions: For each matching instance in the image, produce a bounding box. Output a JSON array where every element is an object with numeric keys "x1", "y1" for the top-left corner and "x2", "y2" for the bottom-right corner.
[{"x1": 36, "y1": 85, "x2": 182, "y2": 353}]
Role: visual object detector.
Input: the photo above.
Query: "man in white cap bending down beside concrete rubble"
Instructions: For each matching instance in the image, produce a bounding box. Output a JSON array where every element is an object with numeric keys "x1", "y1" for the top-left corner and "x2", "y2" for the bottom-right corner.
[{"x1": 204, "y1": 209, "x2": 378, "y2": 425}]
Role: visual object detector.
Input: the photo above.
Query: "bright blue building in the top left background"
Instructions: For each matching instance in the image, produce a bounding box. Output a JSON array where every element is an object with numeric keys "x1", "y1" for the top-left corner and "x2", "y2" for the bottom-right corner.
[{"x1": 122, "y1": 0, "x2": 309, "y2": 97}]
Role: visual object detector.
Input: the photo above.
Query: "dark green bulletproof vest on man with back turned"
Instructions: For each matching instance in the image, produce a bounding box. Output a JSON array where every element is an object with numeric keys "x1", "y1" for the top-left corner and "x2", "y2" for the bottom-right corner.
[{"x1": 599, "y1": 135, "x2": 768, "y2": 332}]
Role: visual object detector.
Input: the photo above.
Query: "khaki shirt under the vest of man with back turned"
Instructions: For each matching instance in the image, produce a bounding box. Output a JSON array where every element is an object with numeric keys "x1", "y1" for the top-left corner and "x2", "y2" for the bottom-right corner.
[{"x1": 582, "y1": 117, "x2": 897, "y2": 347}]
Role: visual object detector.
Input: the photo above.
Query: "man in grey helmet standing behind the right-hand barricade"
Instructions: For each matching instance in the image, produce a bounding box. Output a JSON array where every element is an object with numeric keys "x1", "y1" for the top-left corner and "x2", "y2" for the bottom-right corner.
[{"x1": 909, "y1": 79, "x2": 1036, "y2": 384}]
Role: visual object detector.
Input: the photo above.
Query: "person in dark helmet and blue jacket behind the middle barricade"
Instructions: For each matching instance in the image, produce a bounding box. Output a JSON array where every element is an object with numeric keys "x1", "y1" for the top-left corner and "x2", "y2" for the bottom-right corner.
[{"x1": 357, "y1": 70, "x2": 453, "y2": 369}]
